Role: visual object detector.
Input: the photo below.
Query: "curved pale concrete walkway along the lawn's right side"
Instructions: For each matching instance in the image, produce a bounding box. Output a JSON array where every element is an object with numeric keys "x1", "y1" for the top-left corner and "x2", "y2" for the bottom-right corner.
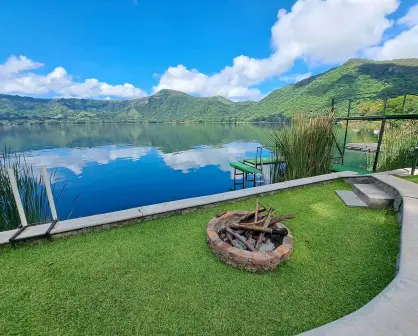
[{"x1": 301, "y1": 174, "x2": 418, "y2": 336}]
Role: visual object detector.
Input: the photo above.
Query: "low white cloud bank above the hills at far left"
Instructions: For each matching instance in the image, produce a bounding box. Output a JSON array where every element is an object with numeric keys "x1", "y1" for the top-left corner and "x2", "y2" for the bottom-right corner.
[{"x1": 0, "y1": 56, "x2": 146, "y2": 98}]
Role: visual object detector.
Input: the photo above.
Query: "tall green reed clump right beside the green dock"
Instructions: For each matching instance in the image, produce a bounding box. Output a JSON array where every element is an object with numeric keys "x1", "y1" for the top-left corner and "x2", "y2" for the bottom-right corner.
[{"x1": 270, "y1": 113, "x2": 334, "y2": 182}]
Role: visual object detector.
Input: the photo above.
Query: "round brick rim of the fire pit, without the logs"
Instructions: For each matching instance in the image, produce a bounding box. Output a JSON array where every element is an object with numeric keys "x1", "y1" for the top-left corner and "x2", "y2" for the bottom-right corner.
[{"x1": 206, "y1": 211, "x2": 293, "y2": 272}]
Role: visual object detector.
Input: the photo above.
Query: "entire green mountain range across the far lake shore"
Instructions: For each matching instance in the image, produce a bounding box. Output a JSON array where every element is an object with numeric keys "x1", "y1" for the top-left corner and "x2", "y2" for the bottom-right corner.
[{"x1": 0, "y1": 59, "x2": 418, "y2": 123}]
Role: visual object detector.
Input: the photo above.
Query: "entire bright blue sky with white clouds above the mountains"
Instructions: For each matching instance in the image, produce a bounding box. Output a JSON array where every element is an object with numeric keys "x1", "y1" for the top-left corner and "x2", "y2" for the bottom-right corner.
[{"x1": 0, "y1": 0, "x2": 418, "y2": 101}]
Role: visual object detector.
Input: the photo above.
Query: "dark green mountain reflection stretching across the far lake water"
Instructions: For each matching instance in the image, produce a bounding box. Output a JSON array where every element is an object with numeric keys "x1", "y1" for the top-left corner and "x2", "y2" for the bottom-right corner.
[{"x1": 0, "y1": 124, "x2": 280, "y2": 153}]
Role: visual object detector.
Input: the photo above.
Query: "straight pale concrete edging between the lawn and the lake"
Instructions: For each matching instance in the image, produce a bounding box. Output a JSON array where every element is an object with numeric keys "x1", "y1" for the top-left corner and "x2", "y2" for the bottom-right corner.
[{"x1": 0, "y1": 172, "x2": 358, "y2": 246}]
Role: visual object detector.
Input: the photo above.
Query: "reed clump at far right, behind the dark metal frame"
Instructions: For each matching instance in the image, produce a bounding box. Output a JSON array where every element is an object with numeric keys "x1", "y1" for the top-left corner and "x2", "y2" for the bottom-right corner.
[{"x1": 368, "y1": 121, "x2": 418, "y2": 171}]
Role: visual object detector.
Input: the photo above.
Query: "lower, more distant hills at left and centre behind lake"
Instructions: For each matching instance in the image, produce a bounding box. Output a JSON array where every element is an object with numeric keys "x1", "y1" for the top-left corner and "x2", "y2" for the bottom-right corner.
[{"x1": 0, "y1": 90, "x2": 256, "y2": 122}]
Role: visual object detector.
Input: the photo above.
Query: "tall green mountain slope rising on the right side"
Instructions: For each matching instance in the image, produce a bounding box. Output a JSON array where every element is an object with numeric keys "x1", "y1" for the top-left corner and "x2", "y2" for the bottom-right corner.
[{"x1": 244, "y1": 59, "x2": 418, "y2": 119}]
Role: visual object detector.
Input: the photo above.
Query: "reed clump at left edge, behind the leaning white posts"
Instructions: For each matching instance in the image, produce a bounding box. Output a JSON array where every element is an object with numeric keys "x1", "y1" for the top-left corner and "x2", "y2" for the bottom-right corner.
[{"x1": 0, "y1": 148, "x2": 54, "y2": 231}]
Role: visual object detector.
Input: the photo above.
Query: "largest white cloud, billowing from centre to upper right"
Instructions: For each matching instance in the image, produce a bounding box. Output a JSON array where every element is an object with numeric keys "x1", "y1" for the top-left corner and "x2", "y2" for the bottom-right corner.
[{"x1": 153, "y1": 0, "x2": 399, "y2": 99}]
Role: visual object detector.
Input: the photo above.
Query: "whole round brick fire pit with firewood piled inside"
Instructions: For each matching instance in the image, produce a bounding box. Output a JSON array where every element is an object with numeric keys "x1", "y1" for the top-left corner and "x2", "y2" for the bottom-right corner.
[{"x1": 206, "y1": 202, "x2": 293, "y2": 272}]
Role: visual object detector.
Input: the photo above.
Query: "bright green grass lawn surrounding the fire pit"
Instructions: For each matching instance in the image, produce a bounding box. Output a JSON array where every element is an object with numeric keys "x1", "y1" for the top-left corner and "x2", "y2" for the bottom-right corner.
[{"x1": 0, "y1": 181, "x2": 399, "y2": 335}]
